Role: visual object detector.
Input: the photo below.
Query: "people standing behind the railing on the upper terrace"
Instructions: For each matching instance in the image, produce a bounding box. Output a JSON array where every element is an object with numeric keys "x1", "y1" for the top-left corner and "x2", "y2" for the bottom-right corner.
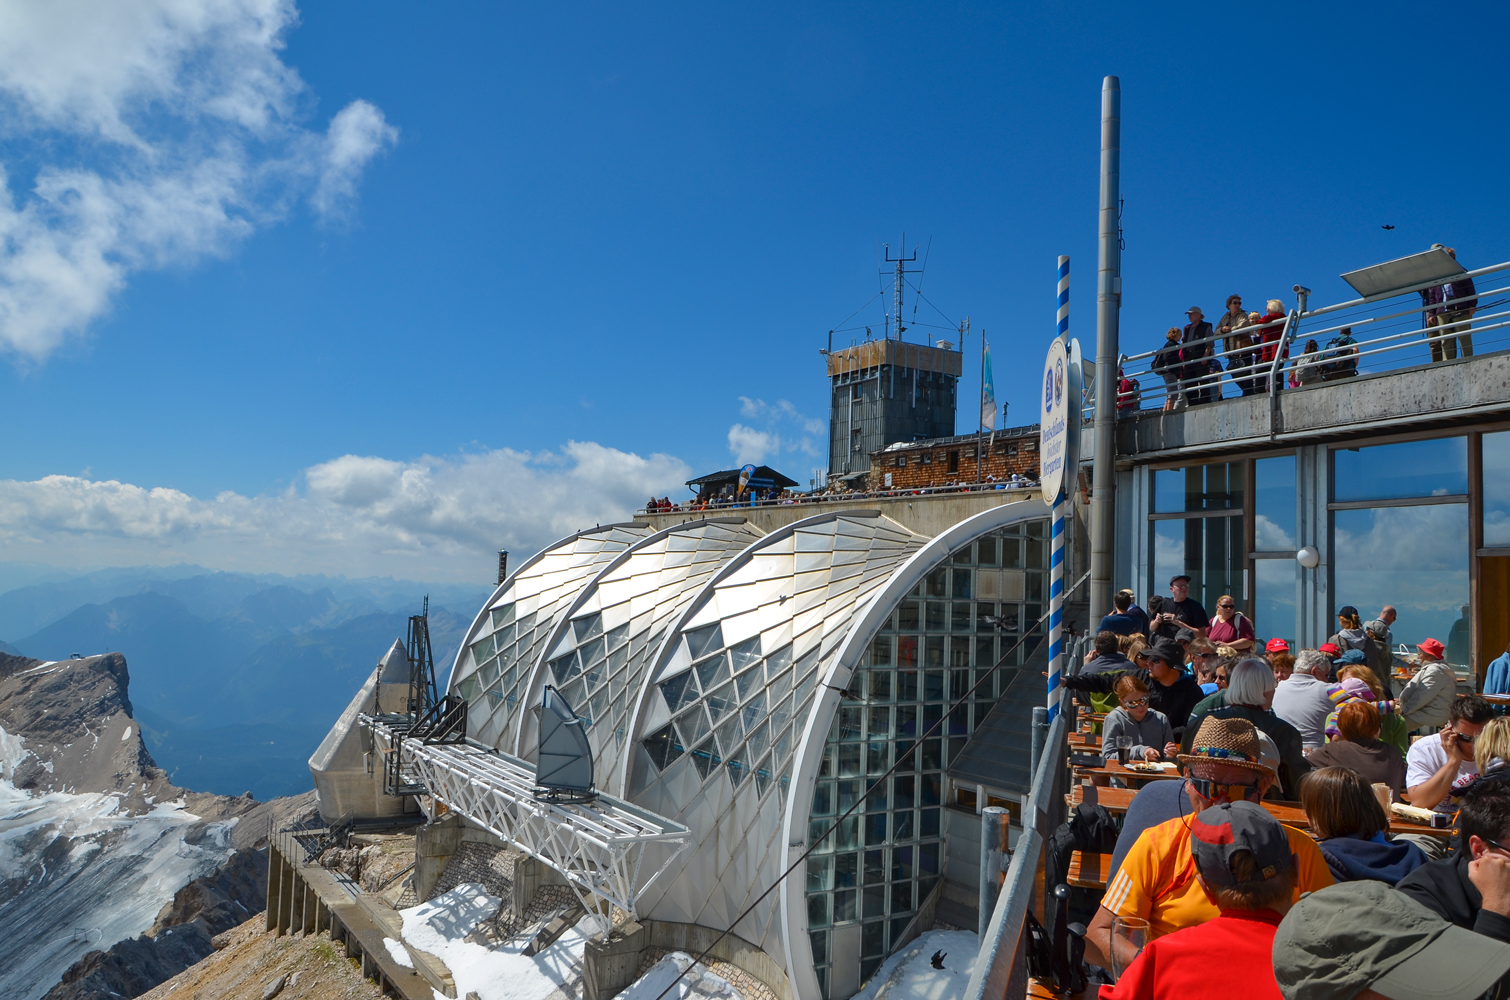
[{"x1": 1117, "y1": 243, "x2": 1478, "y2": 415}]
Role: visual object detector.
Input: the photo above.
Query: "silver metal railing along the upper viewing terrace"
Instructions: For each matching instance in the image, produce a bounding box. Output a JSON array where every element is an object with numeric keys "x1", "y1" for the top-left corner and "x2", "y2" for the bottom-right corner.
[{"x1": 1111, "y1": 261, "x2": 1510, "y2": 418}]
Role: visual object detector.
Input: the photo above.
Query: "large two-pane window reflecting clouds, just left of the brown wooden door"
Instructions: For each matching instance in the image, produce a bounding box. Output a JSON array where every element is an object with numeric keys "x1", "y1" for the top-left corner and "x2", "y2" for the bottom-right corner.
[{"x1": 1326, "y1": 437, "x2": 1467, "y2": 665}]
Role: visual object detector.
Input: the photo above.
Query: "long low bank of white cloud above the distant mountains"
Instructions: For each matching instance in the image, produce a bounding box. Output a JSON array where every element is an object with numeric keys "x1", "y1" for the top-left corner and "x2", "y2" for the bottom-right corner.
[{"x1": 0, "y1": 441, "x2": 690, "y2": 580}]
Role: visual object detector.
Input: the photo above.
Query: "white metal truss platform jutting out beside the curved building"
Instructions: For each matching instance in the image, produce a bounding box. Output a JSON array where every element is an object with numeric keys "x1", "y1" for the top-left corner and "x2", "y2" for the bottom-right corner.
[{"x1": 361, "y1": 715, "x2": 692, "y2": 938}]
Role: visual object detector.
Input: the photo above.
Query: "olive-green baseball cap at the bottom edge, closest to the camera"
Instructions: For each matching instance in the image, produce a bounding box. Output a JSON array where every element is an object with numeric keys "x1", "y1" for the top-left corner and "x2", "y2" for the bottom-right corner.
[{"x1": 1274, "y1": 881, "x2": 1510, "y2": 1000}]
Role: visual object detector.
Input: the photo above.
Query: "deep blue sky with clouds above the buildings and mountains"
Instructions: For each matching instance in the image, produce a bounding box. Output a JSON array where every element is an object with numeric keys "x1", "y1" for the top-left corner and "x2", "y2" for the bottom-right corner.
[{"x1": 0, "y1": 0, "x2": 1510, "y2": 579}]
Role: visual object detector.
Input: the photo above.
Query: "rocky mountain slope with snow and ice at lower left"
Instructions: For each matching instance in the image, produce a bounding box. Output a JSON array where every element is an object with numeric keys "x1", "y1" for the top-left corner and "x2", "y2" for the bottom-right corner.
[{"x1": 0, "y1": 653, "x2": 310, "y2": 1000}]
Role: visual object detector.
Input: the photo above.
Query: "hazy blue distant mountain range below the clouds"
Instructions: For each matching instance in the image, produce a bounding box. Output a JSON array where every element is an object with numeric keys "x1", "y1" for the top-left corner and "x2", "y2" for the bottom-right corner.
[{"x1": 0, "y1": 566, "x2": 489, "y2": 801}]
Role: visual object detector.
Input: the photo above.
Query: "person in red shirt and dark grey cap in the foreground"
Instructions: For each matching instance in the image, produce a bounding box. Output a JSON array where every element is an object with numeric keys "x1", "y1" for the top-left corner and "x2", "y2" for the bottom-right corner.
[{"x1": 1101, "y1": 801, "x2": 1300, "y2": 1000}]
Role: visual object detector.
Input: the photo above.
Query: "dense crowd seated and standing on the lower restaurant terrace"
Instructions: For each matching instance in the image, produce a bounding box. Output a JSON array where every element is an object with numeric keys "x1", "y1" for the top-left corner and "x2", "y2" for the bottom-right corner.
[{"x1": 1063, "y1": 574, "x2": 1510, "y2": 1000}]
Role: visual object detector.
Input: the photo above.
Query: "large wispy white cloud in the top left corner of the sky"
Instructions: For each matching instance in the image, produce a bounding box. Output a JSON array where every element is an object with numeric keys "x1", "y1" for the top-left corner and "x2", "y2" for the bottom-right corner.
[{"x1": 0, "y1": 0, "x2": 397, "y2": 363}]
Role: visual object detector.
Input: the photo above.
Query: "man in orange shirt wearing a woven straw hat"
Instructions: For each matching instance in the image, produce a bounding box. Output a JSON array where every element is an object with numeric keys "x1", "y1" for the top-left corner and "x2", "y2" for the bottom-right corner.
[{"x1": 1086, "y1": 716, "x2": 1332, "y2": 968}]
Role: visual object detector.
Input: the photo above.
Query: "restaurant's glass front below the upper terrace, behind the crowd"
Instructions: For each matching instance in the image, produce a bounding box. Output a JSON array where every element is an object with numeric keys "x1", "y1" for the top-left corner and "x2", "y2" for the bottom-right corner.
[{"x1": 1117, "y1": 427, "x2": 1510, "y2": 672}]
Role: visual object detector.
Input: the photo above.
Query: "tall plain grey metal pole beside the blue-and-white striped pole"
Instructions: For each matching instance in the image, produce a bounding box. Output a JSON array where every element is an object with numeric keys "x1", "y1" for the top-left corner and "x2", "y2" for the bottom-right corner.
[{"x1": 1090, "y1": 77, "x2": 1122, "y2": 628}]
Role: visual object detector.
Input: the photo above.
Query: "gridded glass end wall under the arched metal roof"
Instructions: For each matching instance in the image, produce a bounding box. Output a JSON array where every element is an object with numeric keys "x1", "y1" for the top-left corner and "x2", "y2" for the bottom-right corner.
[{"x1": 806, "y1": 518, "x2": 1049, "y2": 1000}]
